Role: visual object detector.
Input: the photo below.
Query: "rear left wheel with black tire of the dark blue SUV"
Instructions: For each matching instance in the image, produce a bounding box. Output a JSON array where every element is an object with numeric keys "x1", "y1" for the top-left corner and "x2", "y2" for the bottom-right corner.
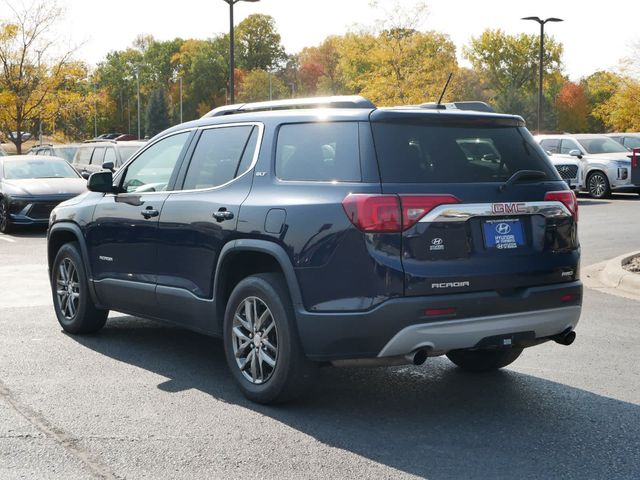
[{"x1": 223, "y1": 273, "x2": 314, "y2": 404}]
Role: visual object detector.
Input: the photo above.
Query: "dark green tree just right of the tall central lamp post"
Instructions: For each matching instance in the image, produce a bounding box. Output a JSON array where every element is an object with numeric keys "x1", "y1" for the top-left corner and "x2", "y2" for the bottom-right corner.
[{"x1": 235, "y1": 13, "x2": 286, "y2": 71}]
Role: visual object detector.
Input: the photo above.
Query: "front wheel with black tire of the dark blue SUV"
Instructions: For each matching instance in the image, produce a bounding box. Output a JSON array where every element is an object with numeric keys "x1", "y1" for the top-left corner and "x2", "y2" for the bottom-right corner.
[{"x1": 51, "y1": 242, "x2": 109, "y2": 334}]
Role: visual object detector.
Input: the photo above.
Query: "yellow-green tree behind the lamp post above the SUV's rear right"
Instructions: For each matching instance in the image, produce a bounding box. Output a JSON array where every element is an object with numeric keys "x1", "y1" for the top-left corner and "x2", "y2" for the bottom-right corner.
[{"x1": 463, "y1": 30, "x2": 564, "y2": 129}]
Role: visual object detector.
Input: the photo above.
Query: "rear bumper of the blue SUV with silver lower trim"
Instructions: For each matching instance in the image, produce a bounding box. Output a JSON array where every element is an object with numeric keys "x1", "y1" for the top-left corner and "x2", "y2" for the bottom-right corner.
[{"x1": 296, "y1": 281, "x2": 582, "y2": 361}]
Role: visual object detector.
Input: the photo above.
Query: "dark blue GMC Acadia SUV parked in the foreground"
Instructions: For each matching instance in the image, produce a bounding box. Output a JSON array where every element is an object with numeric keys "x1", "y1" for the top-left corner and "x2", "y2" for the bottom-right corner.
[{"x1": 48, "y1": 97, "x2": 582, "y2": 403}]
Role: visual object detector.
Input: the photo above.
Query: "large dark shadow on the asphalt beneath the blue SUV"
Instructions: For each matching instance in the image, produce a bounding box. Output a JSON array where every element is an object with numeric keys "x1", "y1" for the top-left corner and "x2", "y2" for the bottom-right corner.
[{"x1": 70, "y1": 316, "x2": 640, "y2": 479}]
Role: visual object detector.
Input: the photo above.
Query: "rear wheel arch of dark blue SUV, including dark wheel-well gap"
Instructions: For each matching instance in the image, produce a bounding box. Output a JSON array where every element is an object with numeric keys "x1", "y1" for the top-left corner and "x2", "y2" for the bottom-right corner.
[{"x1": 213, "y1": 240, "x2": 302, "y2": 325}]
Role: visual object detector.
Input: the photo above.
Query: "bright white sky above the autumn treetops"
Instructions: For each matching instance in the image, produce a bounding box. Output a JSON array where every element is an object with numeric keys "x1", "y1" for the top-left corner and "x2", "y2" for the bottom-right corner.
[{"x1": 52, "y1": 0, "x2": 640, "y2": 80}]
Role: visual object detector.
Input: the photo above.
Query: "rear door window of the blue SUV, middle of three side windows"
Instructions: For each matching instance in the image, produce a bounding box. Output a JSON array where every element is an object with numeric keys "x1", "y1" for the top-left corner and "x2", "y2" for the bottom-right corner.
[{"x1": 182, "y1": 126, "x2": 255, "y2": 190}]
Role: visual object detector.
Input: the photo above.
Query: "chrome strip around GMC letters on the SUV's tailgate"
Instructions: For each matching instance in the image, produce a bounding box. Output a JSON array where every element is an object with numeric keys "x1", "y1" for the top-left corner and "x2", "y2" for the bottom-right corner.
[{"x1": 418, "y1": 201, "x2": 571, "y2": 223}]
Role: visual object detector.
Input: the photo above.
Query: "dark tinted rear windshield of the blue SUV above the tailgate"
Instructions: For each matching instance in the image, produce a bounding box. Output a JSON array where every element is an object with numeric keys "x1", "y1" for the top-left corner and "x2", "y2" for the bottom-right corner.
[{"x1": 373, "y1": 123, "x2": 558, "y2": 183}]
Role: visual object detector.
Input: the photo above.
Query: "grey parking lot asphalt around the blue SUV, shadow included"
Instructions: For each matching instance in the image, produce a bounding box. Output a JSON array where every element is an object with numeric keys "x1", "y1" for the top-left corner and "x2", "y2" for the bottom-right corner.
[{"x1": 0, "y1": 196, "x2": 640, "y2": 479}]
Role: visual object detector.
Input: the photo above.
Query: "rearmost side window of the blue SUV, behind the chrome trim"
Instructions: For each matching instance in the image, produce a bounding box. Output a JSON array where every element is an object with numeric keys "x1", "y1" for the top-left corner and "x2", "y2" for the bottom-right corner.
[{"x1": 276, "y1": 122, "x2": 362, "y2": 182}]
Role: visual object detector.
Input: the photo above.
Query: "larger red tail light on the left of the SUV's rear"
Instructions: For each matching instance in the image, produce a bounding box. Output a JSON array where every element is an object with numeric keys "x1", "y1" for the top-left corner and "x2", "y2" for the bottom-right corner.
[{"x1": 342, "y1": 193, "x2": 460, "y2": 233}]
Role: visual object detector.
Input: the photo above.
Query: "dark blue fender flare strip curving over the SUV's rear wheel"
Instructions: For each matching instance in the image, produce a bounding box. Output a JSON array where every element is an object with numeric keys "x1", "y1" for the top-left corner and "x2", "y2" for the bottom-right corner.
[{"x1": 213, "y1": 239, "x2": 303, "y2": 310}]
